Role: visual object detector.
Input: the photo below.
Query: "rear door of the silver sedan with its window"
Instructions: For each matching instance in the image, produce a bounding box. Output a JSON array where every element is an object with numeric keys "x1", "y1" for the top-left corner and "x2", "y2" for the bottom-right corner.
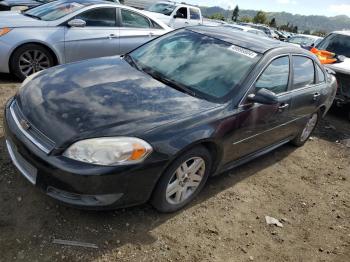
[{"x1": 120, "y1": 8, "x2": 160, "y2": 54}]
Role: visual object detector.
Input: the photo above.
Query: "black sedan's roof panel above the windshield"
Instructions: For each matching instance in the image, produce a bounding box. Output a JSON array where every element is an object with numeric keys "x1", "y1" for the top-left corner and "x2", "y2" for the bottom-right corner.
[{"x1": 187, "y1": 26, "x2": 290, "y2": 54}]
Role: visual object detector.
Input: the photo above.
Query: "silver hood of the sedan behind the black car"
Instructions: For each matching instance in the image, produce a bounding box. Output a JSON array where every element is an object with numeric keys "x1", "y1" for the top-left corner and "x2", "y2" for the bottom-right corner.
[{"x1": 0, "y1": 11, "x2": 47, "y2": 28}]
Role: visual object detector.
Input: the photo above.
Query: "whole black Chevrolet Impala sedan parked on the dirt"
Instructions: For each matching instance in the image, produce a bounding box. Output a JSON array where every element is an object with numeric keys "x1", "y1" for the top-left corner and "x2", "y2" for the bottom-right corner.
[{"x1": 5, "y1": 26, "x2": 337, "y2": 212}]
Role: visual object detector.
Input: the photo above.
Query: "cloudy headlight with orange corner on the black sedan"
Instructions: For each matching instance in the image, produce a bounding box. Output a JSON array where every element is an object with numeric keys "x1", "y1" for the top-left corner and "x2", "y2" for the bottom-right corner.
[{"x1": 63, "y1": 137, "x2": 152, "y2": 166}]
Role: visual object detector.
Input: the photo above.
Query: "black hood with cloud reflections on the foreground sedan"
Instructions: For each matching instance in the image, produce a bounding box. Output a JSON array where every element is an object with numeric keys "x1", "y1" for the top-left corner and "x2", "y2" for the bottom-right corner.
[{"x1": 17, "y1": 57, "x2": 219, "y2": 148}]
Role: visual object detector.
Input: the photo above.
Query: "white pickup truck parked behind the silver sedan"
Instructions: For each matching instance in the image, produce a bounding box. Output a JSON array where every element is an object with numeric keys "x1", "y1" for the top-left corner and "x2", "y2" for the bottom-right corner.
[{"x1": 143, "y1": 1, "x2": 203, "y2": 29}]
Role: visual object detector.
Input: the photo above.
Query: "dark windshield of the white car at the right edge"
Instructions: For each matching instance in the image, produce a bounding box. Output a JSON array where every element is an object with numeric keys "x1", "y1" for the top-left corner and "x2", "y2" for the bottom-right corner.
[{"x1": 317, "y1": 34, "x2": 350, "y2": 58}]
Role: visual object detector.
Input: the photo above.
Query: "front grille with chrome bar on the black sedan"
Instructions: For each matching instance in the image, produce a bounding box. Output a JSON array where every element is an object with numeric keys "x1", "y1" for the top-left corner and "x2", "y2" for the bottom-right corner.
[{"x1": 10, "y1": 101, "x2": 55, "y2": 154}]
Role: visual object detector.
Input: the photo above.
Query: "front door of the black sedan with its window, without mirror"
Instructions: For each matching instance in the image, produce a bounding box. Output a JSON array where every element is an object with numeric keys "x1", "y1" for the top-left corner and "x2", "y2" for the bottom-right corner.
[{"x1": 225, "y1": 55, "x2": 292, "y2": 163}]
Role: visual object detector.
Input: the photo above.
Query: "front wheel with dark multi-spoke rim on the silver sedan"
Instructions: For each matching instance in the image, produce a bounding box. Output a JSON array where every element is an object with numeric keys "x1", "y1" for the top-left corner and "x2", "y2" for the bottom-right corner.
[{"x1": 10, "y1": 44, "x2": 55, "y2": 81}]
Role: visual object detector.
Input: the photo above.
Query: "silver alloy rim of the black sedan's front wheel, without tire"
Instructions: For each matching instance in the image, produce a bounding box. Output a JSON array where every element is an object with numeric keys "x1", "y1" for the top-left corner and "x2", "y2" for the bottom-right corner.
[{"x1": 166, "y1": 157, "x2": 205, "y2": 205}]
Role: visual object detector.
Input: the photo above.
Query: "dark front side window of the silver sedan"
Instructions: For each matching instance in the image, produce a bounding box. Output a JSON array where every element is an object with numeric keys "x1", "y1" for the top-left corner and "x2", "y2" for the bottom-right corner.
[{"x1": 76, "y1": 8, "x2": 116, "y2": 27}]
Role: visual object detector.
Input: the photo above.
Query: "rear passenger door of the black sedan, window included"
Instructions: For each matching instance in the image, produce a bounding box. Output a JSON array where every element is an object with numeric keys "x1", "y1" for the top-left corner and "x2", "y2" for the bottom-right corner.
[{"x1": 290, "y1": 55, "x2": 326, "y2": 129}]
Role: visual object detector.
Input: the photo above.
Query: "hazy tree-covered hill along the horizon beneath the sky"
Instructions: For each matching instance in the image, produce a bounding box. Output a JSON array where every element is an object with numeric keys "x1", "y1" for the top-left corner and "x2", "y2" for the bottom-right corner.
[{"x1": 201, "y1": 6, "x2": 350, "y2": 32}]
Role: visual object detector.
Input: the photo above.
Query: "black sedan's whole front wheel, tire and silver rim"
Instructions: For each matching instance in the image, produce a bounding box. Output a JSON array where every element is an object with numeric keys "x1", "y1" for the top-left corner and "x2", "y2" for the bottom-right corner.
[{"x1": 151, "y1": 146, "x2": 212, "y2": 213}]
